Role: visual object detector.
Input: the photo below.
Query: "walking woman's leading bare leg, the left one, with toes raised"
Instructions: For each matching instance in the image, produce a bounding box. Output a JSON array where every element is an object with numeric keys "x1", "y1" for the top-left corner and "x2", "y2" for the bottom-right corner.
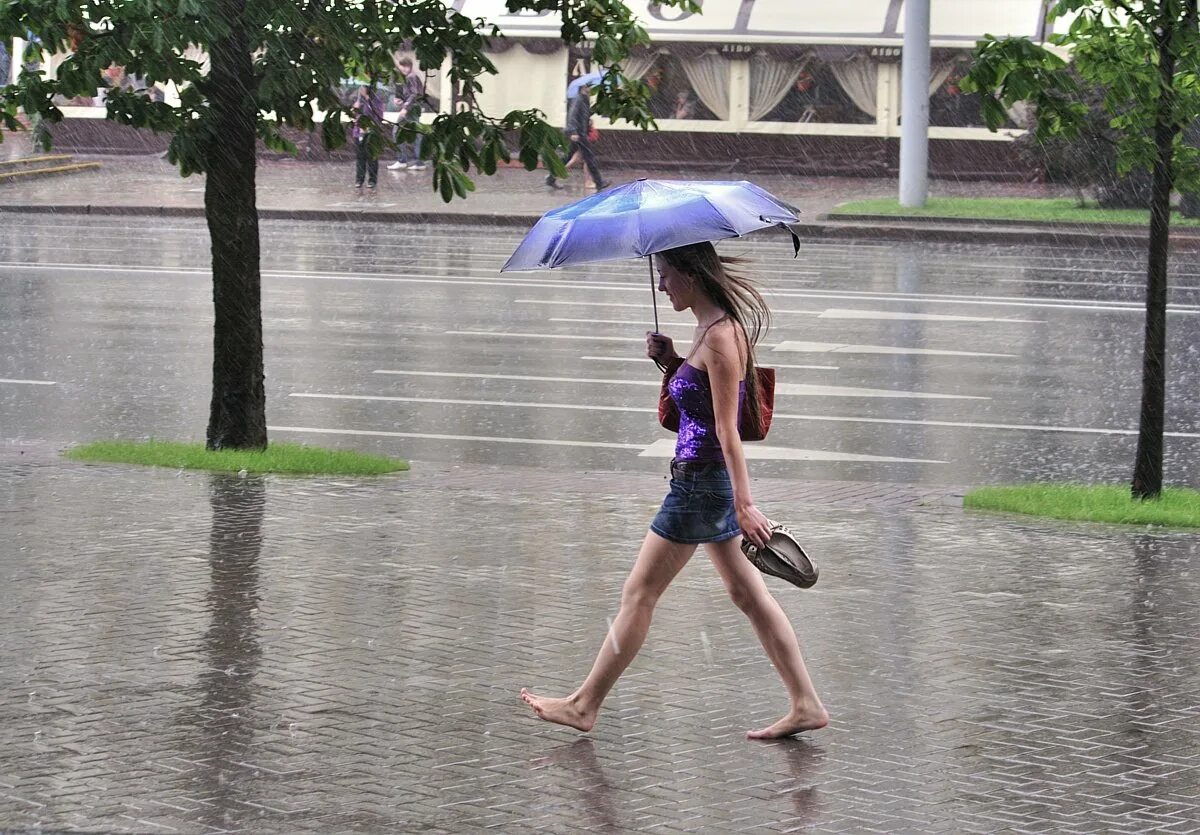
[{"x1": 521, "y1": 531, "x2": 696, "y2": 731}]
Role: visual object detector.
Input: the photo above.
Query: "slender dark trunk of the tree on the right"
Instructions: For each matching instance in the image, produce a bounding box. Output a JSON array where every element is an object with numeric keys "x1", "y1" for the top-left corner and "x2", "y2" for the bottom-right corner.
[{"x1": 1132, "y1": 11, "x2": 1180, "y2": 499}]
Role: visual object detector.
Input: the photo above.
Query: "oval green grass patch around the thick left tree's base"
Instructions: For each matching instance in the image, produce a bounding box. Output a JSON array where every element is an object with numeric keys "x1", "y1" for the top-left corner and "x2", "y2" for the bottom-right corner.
[{"x1": 65, "y1": 440, "x2": 408, "y2": 475}]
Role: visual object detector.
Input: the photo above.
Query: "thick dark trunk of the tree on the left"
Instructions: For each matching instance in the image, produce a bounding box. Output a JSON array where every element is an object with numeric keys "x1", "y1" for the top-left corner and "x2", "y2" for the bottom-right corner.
[{"x1": 204, "y1": 0, "x2": 266, "y2": 450}]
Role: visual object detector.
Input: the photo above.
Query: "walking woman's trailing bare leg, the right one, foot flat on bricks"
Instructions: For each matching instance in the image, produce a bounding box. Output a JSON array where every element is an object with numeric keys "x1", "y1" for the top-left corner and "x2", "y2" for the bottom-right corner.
[{"x1": 704, "y1": 536, "x2": 829, "y2": 739}]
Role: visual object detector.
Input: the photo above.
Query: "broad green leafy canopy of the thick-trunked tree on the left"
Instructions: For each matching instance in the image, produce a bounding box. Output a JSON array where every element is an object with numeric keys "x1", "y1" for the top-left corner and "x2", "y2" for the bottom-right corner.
[{"x1": 0, "y1": 0, "x2": 700, "y2": 200}]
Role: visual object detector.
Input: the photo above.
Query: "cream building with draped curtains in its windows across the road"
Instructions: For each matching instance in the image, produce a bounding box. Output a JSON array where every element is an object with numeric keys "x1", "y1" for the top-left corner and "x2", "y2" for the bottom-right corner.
[{"x1": 8, "y1": 0, "x2": 1049, "y2": 178}]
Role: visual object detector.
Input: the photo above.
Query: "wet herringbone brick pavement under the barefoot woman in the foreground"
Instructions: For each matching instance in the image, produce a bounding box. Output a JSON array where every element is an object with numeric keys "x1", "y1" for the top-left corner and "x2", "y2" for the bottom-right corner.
[{"x1": 0, "y1": 450, "x2": 1200, "y2": 833}]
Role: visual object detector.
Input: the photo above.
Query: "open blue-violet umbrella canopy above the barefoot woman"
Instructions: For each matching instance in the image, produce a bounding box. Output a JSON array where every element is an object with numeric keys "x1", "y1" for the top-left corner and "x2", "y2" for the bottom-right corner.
[{"x1": 500, "y1": 178, "x2": 799, "y2": 272}]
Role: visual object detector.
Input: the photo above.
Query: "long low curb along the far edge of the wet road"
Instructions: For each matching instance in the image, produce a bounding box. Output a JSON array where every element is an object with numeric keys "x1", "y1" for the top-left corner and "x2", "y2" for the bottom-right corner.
[{"x1": 9, "y1": 204, "x2": 1200, "y2": 252}]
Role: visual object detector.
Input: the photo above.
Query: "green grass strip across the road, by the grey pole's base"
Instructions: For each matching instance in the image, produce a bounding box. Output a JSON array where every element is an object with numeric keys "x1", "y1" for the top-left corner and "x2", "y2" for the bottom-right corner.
[{"x1": 833, "y1": 197, "x2": 1200, "y2": 227}]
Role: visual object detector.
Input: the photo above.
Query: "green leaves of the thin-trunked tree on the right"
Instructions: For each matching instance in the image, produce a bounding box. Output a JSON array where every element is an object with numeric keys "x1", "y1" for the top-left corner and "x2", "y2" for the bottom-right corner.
[{"x1": 962, "y1": 0, "x2": 1200, "y2": 191}]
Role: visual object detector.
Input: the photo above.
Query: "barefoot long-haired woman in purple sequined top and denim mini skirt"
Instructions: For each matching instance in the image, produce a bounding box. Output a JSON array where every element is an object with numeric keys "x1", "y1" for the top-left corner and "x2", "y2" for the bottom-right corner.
[{"x1": 521, "y1": 244, "x2": 829, "y2": 739}]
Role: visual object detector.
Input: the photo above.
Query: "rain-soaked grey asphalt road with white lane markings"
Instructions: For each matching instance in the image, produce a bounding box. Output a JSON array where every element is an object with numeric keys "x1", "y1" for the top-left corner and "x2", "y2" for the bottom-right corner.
[{"x1": 0, "y1": 215, "x2": 1200, "y2": 486}]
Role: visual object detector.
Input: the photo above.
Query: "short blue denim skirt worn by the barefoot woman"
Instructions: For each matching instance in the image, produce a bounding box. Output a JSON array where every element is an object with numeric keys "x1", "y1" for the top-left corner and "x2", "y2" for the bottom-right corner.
[{"x1": 650, "y1": 461, "x2": 742, "y2": 545}]
